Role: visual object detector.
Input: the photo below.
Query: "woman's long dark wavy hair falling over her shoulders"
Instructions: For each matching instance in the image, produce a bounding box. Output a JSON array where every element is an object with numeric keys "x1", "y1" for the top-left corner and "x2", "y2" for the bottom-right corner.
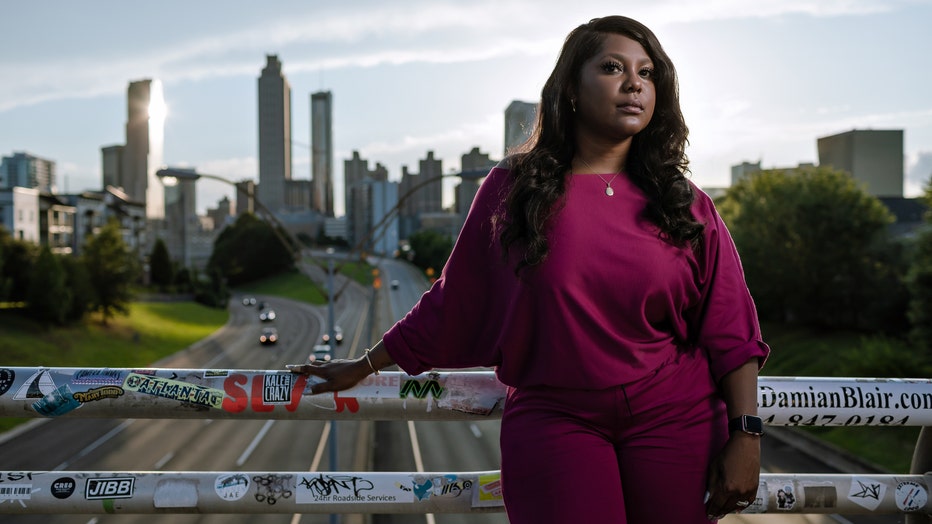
[{"x1": 493, "y1": 16, "x2": 704, "y2": 273}]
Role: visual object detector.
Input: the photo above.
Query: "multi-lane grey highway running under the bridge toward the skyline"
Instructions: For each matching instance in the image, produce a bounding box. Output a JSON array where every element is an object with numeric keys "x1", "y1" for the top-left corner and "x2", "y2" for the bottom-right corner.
[{"x1": 0, "y1": 253, "x2": 903, "y2": 524}]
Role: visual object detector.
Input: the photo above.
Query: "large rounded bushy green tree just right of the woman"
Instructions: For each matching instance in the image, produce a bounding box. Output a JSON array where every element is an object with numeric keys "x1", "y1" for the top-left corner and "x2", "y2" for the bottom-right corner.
[{"x1": 718, "y1": 167, "x2": 901, "y2": 328}]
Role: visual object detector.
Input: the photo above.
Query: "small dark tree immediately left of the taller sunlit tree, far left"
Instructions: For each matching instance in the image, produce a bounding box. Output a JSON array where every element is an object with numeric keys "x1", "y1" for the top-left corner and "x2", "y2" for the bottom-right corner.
[{"x1": 26, "y1": 246, "x2": 71, "y2": 325}]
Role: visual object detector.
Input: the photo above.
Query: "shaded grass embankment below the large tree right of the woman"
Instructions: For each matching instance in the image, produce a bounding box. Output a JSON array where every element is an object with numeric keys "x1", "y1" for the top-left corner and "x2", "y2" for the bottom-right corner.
[{"x1": 761, "y1": 324, "x2": 926, "y2": 473}]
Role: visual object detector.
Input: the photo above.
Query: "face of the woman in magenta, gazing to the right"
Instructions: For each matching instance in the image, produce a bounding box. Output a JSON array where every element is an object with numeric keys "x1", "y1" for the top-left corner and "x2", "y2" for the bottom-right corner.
[{"x1": 573, "y1": 34, "x2": 656, "y2": 140}]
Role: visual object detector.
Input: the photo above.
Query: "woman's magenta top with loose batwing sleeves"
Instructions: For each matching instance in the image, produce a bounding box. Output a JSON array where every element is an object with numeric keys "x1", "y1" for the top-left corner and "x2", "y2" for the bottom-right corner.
[{"x1": 383, "y1": 168, "x2": 770, "y2": 389}]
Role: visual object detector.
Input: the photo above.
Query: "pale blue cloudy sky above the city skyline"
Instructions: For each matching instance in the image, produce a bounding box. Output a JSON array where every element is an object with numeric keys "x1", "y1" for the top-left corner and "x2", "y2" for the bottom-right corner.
[{"x1": 0, "y1": 0, "x2": 932, "y2": 214}]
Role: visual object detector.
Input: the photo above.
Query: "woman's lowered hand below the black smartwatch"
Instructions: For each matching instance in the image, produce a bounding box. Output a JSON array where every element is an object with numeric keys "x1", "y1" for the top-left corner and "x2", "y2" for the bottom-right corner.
[{"x1": 706, "y1": 431, "x2": 760, "y2": 521}]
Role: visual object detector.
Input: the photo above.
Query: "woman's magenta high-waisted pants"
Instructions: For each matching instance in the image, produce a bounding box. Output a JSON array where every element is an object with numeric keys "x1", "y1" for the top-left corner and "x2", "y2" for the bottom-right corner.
[{"x1": 501, "y1": 352, "x2": 728, "y2": 524}]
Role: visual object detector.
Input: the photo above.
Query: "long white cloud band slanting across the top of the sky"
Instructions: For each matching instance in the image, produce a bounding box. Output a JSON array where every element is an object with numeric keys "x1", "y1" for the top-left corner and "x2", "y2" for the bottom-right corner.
[{"x1": 0, "y1": 0, "x2": 909, "y2": 112}]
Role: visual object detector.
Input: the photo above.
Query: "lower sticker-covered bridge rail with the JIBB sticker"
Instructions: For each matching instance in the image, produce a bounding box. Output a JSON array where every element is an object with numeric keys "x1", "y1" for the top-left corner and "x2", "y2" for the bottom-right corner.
[{"x1": 0, "y1": 471, "x2": 930, "y2": 515}]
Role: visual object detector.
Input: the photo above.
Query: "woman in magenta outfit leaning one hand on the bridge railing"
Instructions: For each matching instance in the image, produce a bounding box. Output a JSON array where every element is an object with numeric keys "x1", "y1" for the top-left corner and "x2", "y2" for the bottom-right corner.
[{"x1": 298, "y1": 16, "x2": 769, "y2": 524}]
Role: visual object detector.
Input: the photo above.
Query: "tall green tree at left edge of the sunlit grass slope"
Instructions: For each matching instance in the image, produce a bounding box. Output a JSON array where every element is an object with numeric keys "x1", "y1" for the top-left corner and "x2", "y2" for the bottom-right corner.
[{"x1": 84, "y1": 220, "x2": 139, "y2": 325}]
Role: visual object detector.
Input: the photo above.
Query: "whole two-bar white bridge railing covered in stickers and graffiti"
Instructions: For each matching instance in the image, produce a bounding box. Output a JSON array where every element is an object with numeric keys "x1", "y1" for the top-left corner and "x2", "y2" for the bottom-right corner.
[{"x1": 0, "y1": 367, "x2": 932, "y2": 516}]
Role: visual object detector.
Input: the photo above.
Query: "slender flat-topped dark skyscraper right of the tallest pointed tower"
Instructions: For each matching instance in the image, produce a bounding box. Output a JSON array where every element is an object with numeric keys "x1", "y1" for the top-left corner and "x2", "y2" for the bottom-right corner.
[{"x1": 311, "y1": 91, "x2": 333, "y2": 217}]
